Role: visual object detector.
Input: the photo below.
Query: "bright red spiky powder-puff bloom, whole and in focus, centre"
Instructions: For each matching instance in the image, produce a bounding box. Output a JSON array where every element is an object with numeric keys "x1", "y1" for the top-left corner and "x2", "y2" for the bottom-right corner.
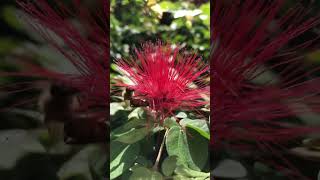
[{"x1": 116, "y1": 42, "x2": 209, "y2": 121}]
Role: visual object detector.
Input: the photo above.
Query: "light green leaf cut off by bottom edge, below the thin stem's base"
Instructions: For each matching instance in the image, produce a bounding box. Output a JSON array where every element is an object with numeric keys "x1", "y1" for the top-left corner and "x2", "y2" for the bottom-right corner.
[{"x1": 129, "y1": 167, "x2": 164, "y2": 180}]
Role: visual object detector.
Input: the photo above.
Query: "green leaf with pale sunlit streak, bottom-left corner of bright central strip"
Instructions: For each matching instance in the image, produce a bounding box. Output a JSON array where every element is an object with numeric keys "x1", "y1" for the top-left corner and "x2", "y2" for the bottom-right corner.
[{"x1": 110, "y1": 141, "x2": 140, "y2": 179}]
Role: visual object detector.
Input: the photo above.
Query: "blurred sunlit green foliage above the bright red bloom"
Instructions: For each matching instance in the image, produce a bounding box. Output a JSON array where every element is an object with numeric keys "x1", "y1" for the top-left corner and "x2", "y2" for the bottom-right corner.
[{"x1": 110, "y1": 0, "x2": 210, "y2": 59}]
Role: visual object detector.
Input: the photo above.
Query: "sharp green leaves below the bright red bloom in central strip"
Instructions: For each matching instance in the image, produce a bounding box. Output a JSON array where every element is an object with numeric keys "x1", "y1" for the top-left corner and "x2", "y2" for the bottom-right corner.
[{"x1": 110, "y1": 103, "x2": 209, "y2": 179}]
